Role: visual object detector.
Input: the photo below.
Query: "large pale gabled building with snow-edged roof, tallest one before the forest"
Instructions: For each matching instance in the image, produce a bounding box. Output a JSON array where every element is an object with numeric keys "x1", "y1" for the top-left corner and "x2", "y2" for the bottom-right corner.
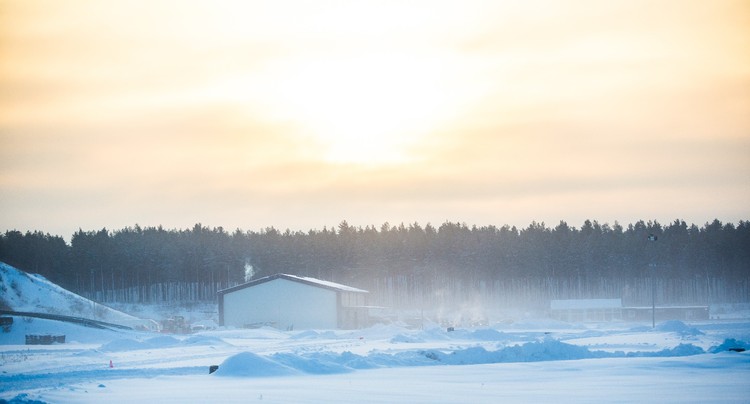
[{"x1": 218, "y1": 274, "x2": 368, "y2": 330}]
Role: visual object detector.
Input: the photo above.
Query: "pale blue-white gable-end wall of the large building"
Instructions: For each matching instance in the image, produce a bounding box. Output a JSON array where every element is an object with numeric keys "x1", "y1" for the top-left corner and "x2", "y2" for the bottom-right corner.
[{"x1": 223, "y1": 279, "x2": 338, "y2": 330}]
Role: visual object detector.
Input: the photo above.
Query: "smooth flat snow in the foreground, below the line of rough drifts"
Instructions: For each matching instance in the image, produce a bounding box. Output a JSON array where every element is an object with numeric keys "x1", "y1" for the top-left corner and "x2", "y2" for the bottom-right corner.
[{"x1": 23, "y1": 353, "x2": 748, "y2": 403}]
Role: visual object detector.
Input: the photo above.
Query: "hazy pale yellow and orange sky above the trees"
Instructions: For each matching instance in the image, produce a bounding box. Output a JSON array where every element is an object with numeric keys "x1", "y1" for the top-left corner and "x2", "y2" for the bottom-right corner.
[{"x1": 0, "y1": 0, "x2": 750, "y2": 238}]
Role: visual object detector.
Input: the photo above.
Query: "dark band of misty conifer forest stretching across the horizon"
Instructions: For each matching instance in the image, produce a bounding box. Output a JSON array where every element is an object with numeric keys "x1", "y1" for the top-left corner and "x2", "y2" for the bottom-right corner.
[{"x1": 0, "y1": 220, "x2": 750, "y2": 301}]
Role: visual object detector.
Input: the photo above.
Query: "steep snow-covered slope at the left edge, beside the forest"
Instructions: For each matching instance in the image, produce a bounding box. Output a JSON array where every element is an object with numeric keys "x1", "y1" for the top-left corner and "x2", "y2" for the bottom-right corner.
[{"x1": 0, "y1": 262, "x2": 144, "y2": 327}]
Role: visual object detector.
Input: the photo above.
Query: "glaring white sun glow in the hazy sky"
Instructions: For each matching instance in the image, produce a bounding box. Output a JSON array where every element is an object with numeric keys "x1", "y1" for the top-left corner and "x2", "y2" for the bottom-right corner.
[{"x1": 264, "y1": 54, "x2": 464, "y2": 165}]
